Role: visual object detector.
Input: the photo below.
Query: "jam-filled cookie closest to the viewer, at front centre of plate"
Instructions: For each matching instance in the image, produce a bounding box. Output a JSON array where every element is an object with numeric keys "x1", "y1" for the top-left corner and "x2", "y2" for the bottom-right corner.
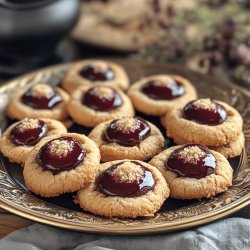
[{"x1": 76, "y1": 160, "x2": 169, "y2": 218}]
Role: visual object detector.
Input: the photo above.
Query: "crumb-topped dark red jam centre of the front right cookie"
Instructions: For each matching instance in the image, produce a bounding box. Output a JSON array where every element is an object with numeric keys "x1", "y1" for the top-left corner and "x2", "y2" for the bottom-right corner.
[{"x1": 165, "y1": 144, "x2": 216, "y2": 179}]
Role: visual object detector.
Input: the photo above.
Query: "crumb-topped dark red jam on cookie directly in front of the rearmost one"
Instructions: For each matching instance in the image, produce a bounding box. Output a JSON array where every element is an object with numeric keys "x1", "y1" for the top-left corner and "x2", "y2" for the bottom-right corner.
[{"x1": 82, "y1": 86, "x2": 123, "y2": 112}]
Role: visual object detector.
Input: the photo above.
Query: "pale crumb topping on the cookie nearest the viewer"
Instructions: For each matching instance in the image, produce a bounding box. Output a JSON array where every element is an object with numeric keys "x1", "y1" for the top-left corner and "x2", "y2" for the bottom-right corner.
[{"x1": 112, "y1": 161, "x2": 144, "y2": 182}]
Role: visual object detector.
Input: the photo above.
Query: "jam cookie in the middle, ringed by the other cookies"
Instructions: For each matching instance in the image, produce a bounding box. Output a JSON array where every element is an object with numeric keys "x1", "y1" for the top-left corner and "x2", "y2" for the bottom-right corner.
[{"x1": 89, "y1": 117, "x2": 164, "y2": 162}]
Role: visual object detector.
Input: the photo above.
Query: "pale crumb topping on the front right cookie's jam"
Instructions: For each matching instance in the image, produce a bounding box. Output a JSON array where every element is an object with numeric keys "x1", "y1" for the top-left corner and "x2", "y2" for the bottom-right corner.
[{"x1": 178, "y1": 146, "x2": 206, "y2": 163}]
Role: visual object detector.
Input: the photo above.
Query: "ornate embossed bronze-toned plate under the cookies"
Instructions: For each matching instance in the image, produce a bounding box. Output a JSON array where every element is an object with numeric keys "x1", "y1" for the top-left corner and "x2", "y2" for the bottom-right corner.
[{"x1": 0, "y1": 59, "x2": 250, "y2": 234}]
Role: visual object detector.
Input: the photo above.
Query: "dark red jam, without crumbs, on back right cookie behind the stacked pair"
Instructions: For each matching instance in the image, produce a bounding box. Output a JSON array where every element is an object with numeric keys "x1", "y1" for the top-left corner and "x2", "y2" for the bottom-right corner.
[{"x1": 141, "y1": 79, "x2": 185, "y2": 100}]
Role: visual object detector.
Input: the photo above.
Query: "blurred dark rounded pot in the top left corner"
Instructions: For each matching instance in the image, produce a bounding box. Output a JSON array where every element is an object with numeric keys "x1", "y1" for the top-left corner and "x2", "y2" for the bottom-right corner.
[{"x1": 0, "y1": 0, "x2": 79, "y2": 73}]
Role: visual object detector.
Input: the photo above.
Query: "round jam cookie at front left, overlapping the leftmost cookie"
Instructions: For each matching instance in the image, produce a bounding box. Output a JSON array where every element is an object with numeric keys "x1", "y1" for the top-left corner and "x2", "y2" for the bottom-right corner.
[{"x1": 23, "y1": 133, "x2": 100, "y2": 197}]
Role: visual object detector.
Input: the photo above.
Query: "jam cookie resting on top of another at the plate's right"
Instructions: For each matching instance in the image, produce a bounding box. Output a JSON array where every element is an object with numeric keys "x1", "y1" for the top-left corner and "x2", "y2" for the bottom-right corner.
[{"x1": 162, "y1": 98, "x2": 243, "y2": 146}]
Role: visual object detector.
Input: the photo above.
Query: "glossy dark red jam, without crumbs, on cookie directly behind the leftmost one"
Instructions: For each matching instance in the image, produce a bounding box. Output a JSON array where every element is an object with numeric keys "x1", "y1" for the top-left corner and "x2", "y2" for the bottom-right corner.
[{"x1": 22, "y1": 85, "x2": 62, "y2": 109}]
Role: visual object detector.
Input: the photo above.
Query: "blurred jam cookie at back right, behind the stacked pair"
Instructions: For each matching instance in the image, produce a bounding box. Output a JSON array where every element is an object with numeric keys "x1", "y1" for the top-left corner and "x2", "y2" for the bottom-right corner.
[{"x1": 128, "y1": 75, "x2": 197, "y2": 116}]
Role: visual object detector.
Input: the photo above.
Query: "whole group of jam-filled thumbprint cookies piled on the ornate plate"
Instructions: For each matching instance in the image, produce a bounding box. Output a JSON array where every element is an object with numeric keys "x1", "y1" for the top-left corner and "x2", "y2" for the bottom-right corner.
[{"x1": 0, "y1": 60, "x2": 244, "y2": 218}]
